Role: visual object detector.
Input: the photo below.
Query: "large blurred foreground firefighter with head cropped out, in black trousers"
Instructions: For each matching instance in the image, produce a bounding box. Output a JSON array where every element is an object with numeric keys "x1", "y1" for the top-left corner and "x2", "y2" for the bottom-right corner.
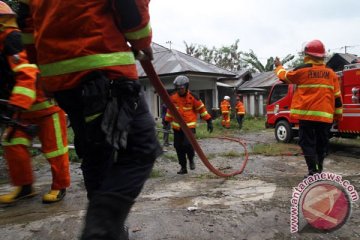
[{"x1": 19, "y1": 0, "x2": 162, "y2": 239}]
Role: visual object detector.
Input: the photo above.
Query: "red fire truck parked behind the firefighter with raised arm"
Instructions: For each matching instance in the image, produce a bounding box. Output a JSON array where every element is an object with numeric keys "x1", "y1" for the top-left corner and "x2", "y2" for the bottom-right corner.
[{"x1": 265, "y1": 63, "x2": 360, "y2": 143}]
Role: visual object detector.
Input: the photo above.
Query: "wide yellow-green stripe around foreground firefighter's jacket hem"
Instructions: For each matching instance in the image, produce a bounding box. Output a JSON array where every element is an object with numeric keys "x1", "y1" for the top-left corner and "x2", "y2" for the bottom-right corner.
[{"x1": 39, "y1": 52, "x2": 135, "y2": 77}]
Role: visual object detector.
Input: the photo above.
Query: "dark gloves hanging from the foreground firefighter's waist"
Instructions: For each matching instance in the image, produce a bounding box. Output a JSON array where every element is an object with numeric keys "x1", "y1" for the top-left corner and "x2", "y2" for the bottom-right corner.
[{"x1": 101, "y1": 80, "x2": 141, "y2": 150}]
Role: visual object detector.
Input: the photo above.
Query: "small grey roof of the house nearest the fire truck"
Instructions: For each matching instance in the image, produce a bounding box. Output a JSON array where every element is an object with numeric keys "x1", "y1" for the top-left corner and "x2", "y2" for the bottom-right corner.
[{"x1": 238, "y1": 71, "x2": 279, "y2": 90}]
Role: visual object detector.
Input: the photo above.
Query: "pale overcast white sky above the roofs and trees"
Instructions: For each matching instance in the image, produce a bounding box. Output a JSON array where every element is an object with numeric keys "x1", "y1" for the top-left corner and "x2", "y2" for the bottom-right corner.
[{"x1": 150, "y1": 0, "x2": 360, "y2": 62}]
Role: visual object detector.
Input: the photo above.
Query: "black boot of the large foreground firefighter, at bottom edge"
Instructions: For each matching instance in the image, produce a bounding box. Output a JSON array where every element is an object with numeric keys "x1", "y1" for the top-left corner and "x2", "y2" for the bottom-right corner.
[{"x1": 81, "y1": 192, "x2": 134, "y2": 240}]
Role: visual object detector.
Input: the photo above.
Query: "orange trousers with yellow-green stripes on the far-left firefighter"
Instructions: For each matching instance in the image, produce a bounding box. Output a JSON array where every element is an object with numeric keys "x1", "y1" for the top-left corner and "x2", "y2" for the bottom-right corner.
[{"x1": 2, "y1": 110, "x2": 70, "y2": 190}]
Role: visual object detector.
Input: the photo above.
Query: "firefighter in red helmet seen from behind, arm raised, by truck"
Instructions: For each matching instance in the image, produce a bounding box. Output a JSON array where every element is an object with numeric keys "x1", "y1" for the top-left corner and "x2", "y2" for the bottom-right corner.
[{"x1": 275, "y1": 40, "x2": 342, "y2": 176}]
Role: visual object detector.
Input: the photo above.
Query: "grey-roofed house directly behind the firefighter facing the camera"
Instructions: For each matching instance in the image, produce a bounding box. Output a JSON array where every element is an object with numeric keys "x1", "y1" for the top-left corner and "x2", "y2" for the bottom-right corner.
[{"x1": 137, "y1": 43, "x2": 236, "y2": 118}]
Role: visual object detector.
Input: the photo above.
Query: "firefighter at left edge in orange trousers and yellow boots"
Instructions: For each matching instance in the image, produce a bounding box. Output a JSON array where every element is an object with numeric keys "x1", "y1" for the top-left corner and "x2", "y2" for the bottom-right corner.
[{"x1": 0, "y1": 1, "x2": 70, "y2": 204}]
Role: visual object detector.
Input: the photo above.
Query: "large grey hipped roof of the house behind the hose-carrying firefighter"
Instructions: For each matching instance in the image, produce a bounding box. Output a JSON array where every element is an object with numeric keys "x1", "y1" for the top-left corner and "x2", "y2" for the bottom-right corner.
[{"x1": 136, "y1": 43, "x2": 236, "y2": 77}]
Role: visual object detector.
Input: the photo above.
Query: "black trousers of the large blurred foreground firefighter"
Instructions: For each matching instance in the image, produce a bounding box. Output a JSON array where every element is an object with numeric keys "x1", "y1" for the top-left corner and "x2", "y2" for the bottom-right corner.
[{"x1": 55, "y1": 80, "x2": 162, "y2": 201}]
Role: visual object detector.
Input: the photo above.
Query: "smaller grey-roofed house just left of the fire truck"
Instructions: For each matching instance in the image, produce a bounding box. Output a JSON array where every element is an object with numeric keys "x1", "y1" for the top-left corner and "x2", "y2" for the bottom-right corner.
[{"x1": 236, "y1": 71, "x2": 278, "y2": 117}]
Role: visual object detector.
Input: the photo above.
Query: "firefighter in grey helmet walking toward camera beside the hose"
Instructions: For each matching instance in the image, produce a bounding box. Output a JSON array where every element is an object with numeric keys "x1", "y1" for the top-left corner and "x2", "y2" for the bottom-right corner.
[{"x1": 165, "y1": 75, "x2": 213, "y2": 174}]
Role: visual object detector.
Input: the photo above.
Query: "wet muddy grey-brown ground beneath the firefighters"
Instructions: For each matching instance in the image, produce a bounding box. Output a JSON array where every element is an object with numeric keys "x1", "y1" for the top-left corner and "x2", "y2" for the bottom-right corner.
[{"x1": 0, "y1": 131, "x2": 360, "y2": 240}]
